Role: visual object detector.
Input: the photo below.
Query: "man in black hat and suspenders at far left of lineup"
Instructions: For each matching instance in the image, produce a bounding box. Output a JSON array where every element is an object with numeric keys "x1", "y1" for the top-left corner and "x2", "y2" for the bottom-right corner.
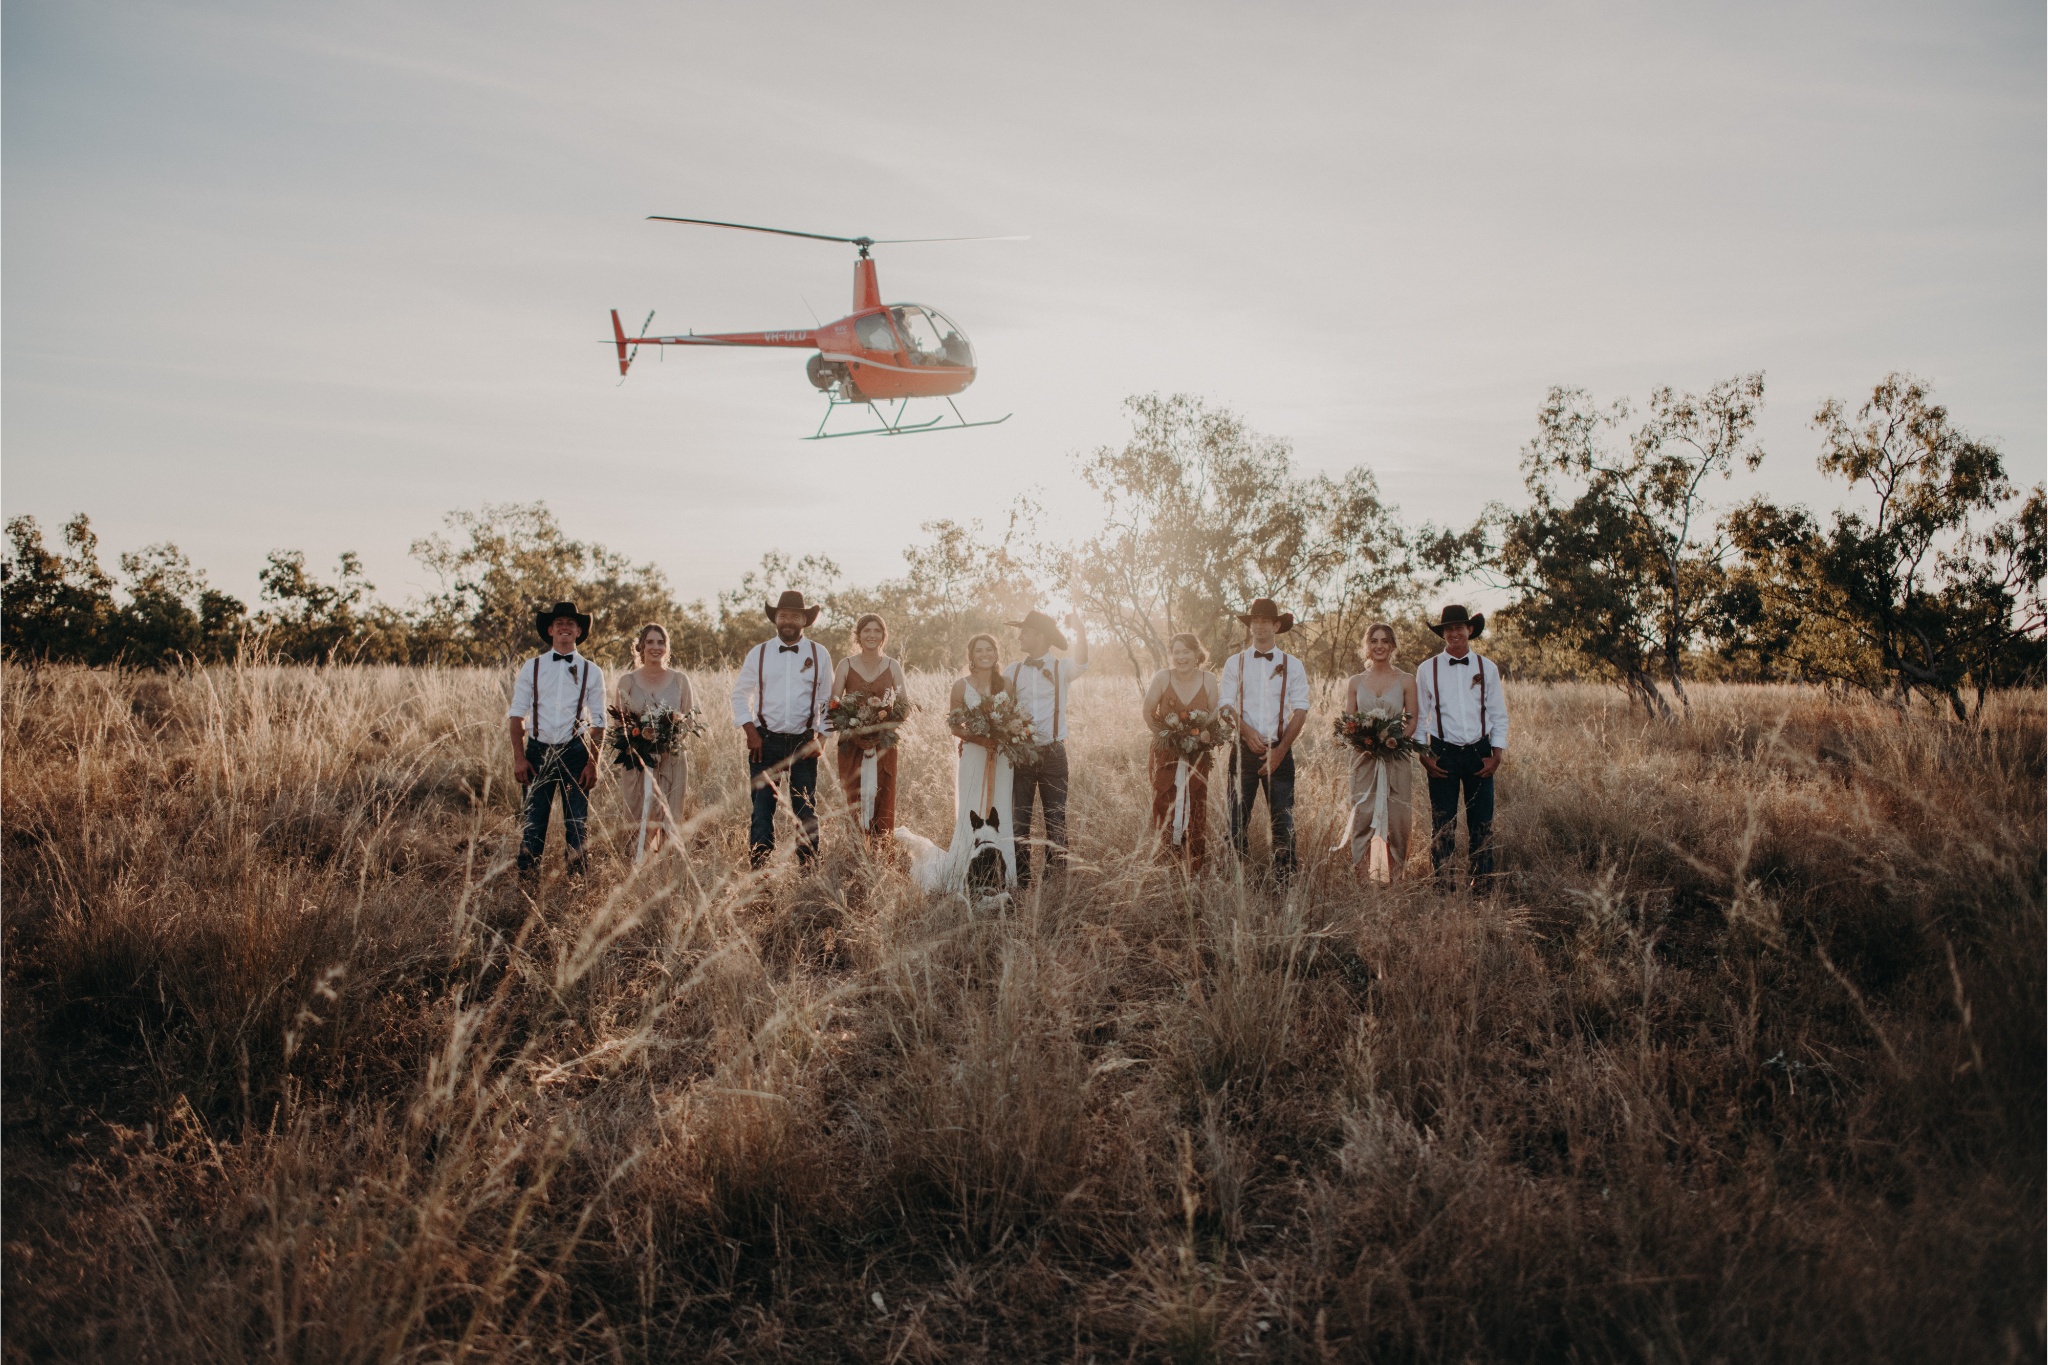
[{"x1": 506, "y1": 602, "x2": 604, "y2": 874}]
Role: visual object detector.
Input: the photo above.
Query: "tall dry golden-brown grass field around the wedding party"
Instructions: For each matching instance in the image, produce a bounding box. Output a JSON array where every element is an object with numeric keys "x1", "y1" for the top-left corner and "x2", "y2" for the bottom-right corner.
[{"x1": 0, "y1": 667, "x2": 2048, "y2": 1363}]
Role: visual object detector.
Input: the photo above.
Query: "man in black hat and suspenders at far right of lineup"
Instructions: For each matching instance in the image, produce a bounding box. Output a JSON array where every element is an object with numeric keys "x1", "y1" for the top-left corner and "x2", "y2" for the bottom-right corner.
[{"x1": 1415, "y1": 606, "x2": 1507, "y2": 890}]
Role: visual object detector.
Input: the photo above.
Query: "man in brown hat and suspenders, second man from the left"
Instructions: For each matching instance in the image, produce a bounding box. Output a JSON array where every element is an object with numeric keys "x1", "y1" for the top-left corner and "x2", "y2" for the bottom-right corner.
[{"x1": 733, "y1": 591, "x2": 831, "y2": 868}]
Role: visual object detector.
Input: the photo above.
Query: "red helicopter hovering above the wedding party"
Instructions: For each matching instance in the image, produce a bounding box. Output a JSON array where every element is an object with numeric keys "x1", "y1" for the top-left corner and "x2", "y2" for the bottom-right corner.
[{"x1": 612, "y1": 213, "x2": 1024, "y2": 440}]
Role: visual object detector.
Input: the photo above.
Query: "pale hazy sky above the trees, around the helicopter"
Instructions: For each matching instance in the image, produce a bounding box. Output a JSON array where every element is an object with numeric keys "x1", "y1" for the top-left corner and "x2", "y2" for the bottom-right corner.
[{"x1": 0, "y1": 0, "x2": 2048, "y2": 600}]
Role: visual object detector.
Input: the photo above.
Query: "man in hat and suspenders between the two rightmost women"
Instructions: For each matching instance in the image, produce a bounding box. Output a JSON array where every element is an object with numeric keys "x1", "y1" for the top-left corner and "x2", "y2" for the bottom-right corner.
[{"x1": 1219, "y1": 598, "x2": 1309, "y2": 882}]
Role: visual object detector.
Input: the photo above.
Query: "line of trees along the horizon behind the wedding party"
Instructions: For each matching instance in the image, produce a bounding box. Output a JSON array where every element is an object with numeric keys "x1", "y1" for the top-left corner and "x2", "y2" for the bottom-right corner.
[{"x1": 0, "y1": 372, "x2": 2048, "y2": 716}]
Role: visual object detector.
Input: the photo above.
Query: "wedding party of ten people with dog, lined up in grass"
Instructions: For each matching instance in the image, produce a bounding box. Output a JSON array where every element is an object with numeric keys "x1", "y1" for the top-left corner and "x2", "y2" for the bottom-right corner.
[{"x1": 506, "y1": 591, "x2": 1507, "y2": 896}]
